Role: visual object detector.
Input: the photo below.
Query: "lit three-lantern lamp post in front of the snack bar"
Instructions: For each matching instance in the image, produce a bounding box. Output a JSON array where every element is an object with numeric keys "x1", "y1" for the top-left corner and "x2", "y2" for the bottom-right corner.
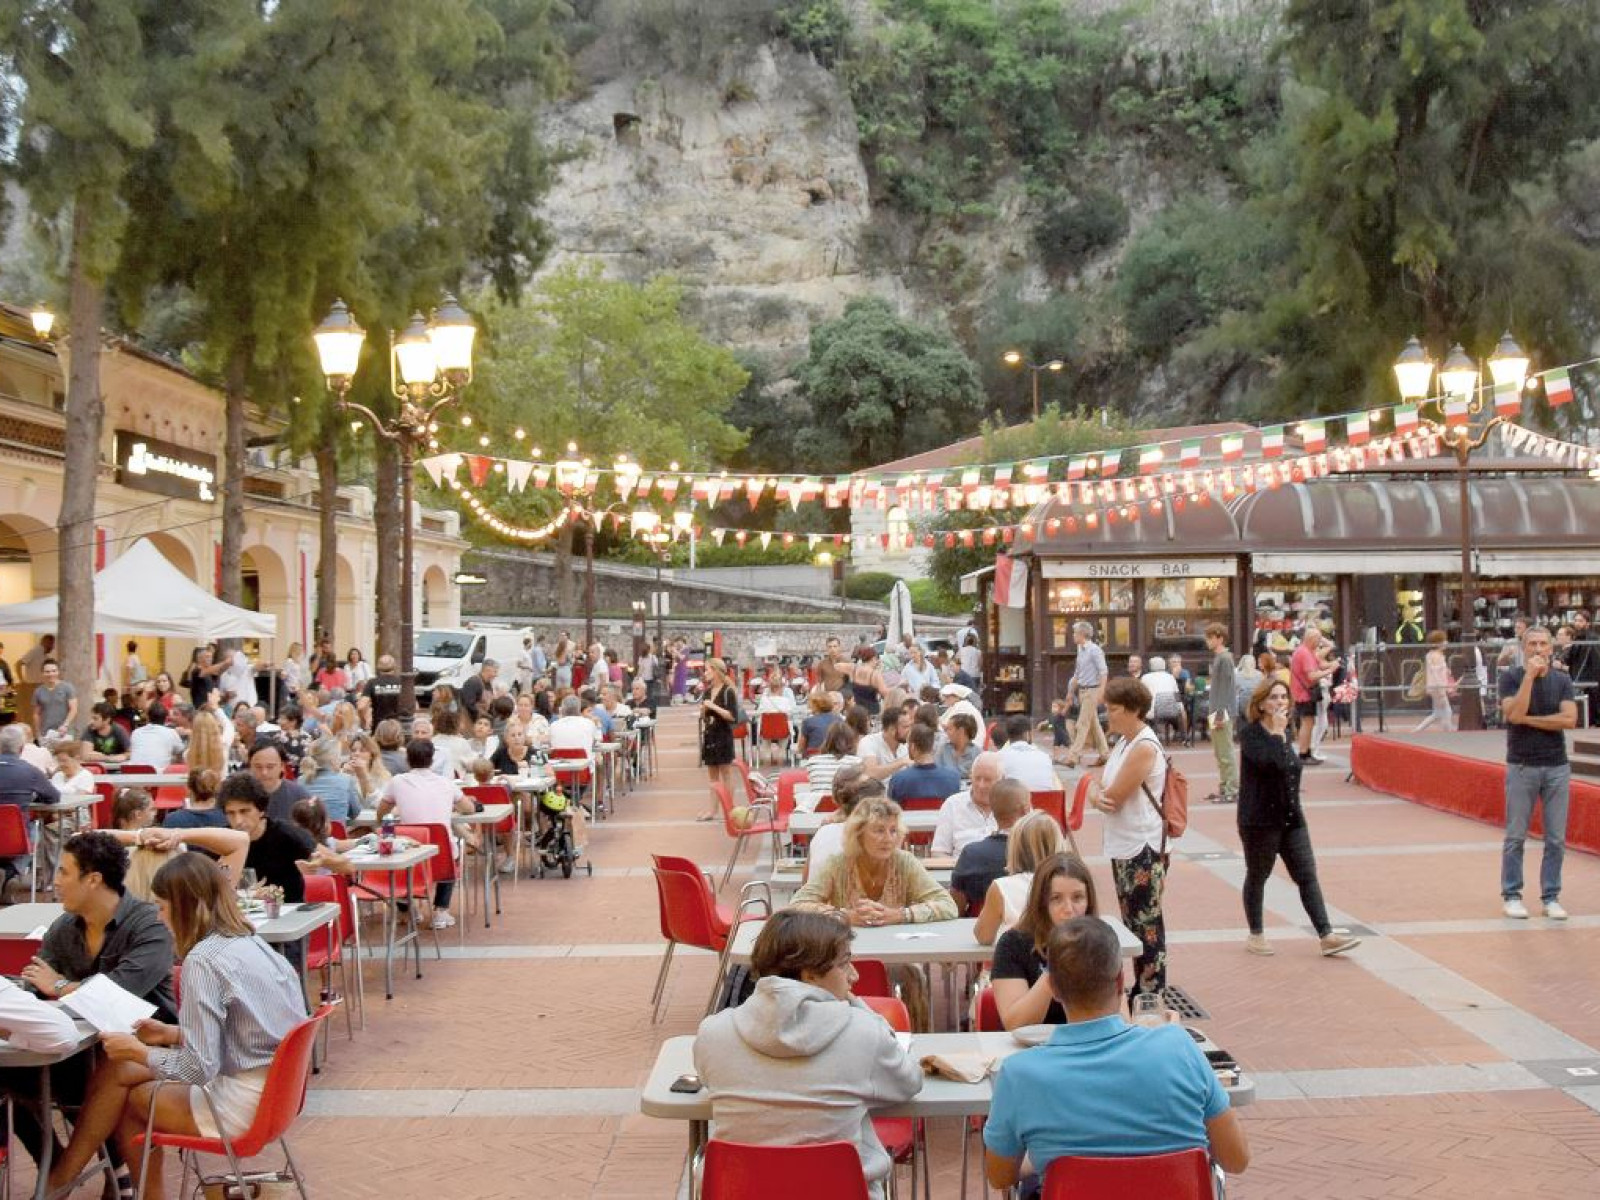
[{"x1": 1394, "y1": 330, "x2": 1528, "y2": 730}]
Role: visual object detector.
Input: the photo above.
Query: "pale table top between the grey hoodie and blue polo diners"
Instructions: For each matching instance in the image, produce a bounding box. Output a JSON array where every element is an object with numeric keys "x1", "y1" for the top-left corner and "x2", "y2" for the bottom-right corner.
[{"x1": 638, "y1": 1034, "x2": 1256, "y2": 1122}]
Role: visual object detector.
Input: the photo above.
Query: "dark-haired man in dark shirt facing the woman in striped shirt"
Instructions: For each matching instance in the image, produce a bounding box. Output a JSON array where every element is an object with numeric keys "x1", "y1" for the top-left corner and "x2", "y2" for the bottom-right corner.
[{"x1": 0, "y1": 830, "x2": 178, "y2": 1162}]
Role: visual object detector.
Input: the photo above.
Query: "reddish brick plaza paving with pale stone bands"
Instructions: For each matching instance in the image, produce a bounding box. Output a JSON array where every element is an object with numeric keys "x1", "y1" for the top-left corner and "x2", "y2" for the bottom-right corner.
[{"x1": 37, "y1": 709, "x2": 1600, "y2": 1200}]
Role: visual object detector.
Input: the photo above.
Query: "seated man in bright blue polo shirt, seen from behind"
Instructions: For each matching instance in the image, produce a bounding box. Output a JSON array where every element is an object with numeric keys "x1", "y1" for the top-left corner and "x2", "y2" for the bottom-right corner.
[{"x1": 984, "y1": 917, "x2": 1250, "y2": 1189}]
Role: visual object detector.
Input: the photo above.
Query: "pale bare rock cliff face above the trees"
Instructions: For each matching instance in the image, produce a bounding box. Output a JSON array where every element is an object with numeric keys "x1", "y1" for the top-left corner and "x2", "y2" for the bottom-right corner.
[{"x1": 528, "y1": 43, "x2": 904, "y2": 360}]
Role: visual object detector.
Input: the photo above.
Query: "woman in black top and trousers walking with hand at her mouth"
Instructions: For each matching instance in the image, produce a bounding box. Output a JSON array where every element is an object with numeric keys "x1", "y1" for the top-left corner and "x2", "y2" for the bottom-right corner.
[{"x1": 1238, "y1": 677, "x2": 1362, "y2": 957}]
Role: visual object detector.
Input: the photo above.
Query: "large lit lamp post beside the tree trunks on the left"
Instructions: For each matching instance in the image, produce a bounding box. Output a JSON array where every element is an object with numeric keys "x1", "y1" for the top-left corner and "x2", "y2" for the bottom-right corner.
[{"x1": 312, "y1": 293, "x2": 477, "y2": 731}]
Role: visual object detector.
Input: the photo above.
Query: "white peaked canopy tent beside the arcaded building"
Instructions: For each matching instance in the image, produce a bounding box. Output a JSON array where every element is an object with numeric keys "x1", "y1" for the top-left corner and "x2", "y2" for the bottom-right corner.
[{"x1": 0, "y1": 538, "x2": 278, "y2": 642}]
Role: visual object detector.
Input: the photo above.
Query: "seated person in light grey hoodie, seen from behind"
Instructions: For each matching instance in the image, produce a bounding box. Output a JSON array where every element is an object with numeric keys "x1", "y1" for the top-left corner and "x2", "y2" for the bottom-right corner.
[{"x1": 694, "y1": 909, "x2": 922, "y2": 1200}]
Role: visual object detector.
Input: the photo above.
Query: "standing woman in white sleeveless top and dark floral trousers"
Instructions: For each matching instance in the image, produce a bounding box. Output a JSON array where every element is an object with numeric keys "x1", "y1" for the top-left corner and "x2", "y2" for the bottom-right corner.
[{"x1": 1088, "y1": 677, "x2": 1166, "y2": 1003}]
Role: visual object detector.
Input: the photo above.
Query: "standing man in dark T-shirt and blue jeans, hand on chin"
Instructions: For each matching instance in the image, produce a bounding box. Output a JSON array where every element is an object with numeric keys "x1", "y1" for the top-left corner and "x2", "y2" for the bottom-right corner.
[{"x1": 1499, "y1": 626, "x2": 1578, "y2": 922}]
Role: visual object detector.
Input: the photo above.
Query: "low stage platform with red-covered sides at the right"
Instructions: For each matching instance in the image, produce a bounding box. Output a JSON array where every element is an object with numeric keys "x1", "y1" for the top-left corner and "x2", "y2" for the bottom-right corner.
[{"x1": 1350, "y1": 733, "x2": 1600, "y2": 854}]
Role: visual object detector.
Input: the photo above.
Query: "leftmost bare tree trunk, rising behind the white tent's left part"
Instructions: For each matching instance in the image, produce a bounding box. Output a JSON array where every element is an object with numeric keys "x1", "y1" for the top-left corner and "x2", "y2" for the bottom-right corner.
[{"x1": 55, "y1": 195, "x2": 106, "y2": 713}]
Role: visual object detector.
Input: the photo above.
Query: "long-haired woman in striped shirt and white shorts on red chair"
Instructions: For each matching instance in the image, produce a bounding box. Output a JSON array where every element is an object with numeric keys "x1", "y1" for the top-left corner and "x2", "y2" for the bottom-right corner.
[{"x1": 50, "y1": 853, "x2": 306, "y2": 1200}]
